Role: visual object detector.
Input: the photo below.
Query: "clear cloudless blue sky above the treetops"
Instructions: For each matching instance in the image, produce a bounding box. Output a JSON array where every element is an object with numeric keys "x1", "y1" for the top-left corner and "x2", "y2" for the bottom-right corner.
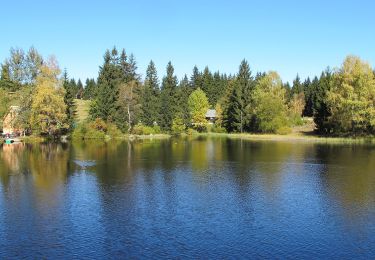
[{"x1": 0, "y1": 0, "x2": 375, "y2": 81}]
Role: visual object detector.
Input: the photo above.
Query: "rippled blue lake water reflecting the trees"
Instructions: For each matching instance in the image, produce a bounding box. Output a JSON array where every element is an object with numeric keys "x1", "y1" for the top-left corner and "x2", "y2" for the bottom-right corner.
[{"x1": 0, "y1": 138, "x2": 375, "y2": 259}]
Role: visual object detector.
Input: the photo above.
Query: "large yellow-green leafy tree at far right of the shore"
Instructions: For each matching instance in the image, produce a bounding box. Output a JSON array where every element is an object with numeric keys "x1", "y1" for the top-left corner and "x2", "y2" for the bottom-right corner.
[{"x1": 326, "y1": 56, "x2": 375, "y2": 135}]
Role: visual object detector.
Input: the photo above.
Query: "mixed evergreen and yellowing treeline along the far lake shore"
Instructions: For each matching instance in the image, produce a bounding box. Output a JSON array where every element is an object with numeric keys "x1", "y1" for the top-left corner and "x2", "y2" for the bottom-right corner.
[{"x1": 0, "y1": 48, "x2": 375, "y2": 137}]
